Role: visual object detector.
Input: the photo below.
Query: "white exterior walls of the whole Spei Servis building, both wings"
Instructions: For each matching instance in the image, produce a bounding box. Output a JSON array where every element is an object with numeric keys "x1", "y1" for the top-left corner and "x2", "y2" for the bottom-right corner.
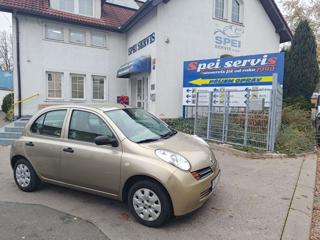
[{"x1": 13, "y1": 0, "x2": 280, "y2": 118}]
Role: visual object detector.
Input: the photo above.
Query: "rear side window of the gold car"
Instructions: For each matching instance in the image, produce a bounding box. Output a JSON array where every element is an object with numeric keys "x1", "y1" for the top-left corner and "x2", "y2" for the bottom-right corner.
[{"x1": 30, "y1": 110, "x2": 67, "y2": 137}]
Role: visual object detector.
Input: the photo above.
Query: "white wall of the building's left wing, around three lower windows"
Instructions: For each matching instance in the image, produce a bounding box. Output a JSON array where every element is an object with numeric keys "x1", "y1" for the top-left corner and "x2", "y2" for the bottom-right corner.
[{"x1": 13, "y1": 16, "x2": 128, "y2": 115}]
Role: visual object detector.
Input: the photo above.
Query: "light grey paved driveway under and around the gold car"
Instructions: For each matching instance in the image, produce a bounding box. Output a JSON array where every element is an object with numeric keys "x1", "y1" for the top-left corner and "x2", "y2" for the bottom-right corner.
[{"x1": 0, "y1": 147, "x2": 314, "y2": 240}]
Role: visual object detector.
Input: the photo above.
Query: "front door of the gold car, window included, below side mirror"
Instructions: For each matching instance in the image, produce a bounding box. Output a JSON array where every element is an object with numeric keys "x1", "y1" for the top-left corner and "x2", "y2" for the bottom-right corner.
[{"x1": 61, "y1": 109, "x2": 122, "y2": 195}]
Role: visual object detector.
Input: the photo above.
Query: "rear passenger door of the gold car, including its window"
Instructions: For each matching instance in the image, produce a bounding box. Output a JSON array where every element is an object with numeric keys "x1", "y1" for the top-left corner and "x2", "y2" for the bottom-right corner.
[{"x1": 23, "y1": 109, "x2": 67, "y2": 180}]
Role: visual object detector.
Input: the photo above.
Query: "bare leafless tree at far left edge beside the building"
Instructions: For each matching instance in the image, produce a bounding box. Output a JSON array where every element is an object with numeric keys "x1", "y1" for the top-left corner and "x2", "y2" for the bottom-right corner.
[{"x1": 0, "y1": 31, "x2": 13, "y2": 71}]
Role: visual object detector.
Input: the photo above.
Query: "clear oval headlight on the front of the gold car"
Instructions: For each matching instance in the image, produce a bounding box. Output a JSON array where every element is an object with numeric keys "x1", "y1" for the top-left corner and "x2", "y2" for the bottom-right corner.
[{"x1": 155, "y1": 149, "x2": 191, "y2": 171}]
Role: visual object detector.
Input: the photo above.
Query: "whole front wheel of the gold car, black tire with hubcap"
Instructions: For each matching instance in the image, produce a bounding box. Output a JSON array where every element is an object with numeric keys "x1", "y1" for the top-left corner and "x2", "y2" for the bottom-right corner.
[{"x1": 127, "y1": 180, "x2": 172, "y2": 227}]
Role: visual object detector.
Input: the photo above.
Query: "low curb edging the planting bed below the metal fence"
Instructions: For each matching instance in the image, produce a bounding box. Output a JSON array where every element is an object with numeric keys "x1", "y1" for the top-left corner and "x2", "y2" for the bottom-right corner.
[{"x1": 207, "y1": 142, "x2": 316, "y2": 160}]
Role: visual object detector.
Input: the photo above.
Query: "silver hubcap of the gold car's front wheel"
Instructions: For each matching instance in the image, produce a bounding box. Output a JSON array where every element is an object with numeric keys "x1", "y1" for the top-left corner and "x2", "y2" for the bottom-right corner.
[{"x1": 132, "y1": 188, "x2": 161, "y2": 221}]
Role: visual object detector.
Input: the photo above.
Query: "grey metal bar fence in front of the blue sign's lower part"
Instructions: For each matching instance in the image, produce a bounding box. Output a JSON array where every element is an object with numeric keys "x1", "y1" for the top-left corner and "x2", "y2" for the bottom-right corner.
[{"x1": 185, "y1": 75, "x2": 282, "y2": 151}]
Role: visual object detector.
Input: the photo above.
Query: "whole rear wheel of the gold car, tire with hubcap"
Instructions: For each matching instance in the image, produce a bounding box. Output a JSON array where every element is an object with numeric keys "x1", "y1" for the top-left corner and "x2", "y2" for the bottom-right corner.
[{"x1": 13, "y1": 158, "x2": 41, "y2": 192}]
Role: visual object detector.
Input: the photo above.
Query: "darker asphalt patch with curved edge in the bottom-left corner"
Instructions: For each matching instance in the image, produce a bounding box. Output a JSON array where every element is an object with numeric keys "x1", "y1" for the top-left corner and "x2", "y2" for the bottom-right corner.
[{"x1": 0, "y1": 202, "x2": 108, "y2": 240}]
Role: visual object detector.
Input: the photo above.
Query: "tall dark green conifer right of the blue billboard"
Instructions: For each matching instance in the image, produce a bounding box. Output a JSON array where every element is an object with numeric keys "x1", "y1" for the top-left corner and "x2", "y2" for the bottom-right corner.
[{"x1": 284, "y1": 20, "x2": 320, "y2": 99}]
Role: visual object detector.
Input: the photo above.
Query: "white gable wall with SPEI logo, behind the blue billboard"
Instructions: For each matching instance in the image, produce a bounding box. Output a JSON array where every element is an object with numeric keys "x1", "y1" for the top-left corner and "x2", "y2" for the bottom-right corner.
[{"x1": 156, "y1": 0, "x2": 279, "y2": 117}]
